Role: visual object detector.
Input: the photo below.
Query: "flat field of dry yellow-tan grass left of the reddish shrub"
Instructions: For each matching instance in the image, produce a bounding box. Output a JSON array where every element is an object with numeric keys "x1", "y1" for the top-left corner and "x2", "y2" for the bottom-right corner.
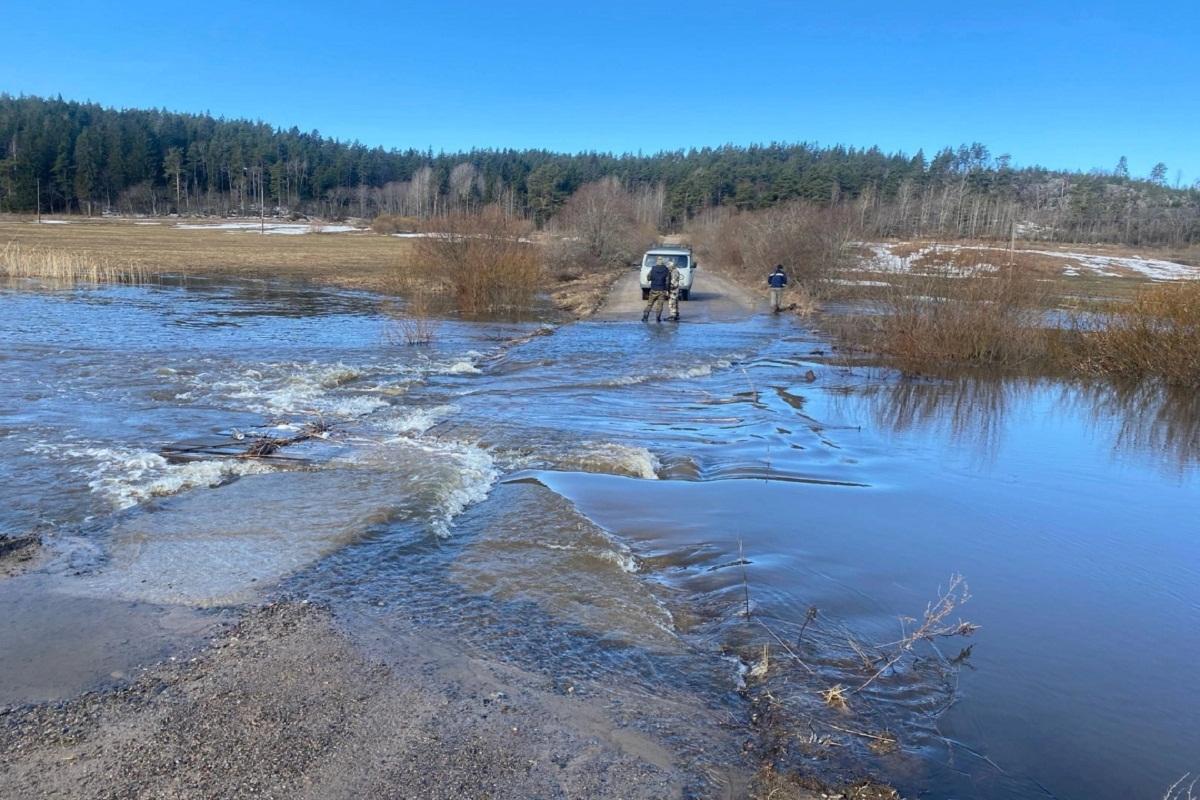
[{"x1": 0, "y1": 217, "x2": 414, "y2": 291}]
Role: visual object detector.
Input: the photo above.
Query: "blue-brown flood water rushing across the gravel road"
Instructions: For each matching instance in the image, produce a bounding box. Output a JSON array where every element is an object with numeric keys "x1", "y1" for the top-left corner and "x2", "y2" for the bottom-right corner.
[{"x1": 0, "y1": 277, "x2": 1200, "y2": 800}]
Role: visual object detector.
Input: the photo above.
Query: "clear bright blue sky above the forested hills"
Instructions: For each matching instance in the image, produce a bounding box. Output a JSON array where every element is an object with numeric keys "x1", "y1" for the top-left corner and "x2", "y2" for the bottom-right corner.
[{"x1": 0, "y1": 0, "x2": 1200, "y2": 184}]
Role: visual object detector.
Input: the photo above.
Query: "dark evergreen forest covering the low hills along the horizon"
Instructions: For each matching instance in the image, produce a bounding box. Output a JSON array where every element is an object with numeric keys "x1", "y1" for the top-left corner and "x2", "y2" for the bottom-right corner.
[{"x1": 0, "y1": 95, "x2": 1200, "y2": 246}]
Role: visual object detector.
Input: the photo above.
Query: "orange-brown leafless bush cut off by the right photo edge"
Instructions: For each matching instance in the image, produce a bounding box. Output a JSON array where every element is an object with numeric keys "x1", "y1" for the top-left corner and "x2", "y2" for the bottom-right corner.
[{"x1": 1079, "y1": 281, "x2": 1200, "y2": 389}]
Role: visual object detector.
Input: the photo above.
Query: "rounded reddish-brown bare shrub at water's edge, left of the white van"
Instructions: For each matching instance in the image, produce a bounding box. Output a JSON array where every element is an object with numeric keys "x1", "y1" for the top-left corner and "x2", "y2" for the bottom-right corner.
[{"x1": 415, "y1": 205, "x2": 542, "y2": 314}]
